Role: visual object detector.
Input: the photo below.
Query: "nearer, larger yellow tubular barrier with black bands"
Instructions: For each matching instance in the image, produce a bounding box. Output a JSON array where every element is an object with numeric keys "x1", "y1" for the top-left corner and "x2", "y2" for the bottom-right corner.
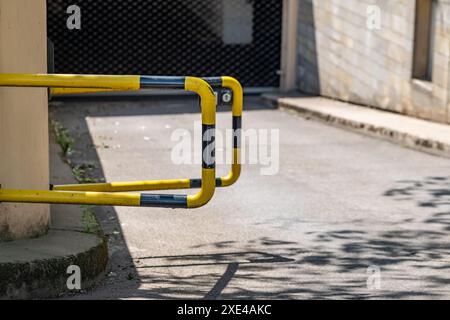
[{"x1": 0, "y1": 74, "x2": 216, "y2": 208}]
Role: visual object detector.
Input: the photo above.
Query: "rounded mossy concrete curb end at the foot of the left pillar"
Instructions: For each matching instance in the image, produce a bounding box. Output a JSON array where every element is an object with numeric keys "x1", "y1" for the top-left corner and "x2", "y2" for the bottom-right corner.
[{"x1": 0, "y1": 230, "x2": 108, "y2": 300}]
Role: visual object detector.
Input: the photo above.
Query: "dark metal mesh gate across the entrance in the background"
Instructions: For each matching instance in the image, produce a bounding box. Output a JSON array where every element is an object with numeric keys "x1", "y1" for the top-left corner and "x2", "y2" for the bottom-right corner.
[{"x1": 47, "y1": 0, "x2": 282, "y2": 87}]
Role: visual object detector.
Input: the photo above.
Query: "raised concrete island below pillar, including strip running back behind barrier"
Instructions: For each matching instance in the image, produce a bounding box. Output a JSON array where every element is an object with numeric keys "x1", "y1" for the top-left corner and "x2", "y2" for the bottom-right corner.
[{"x1": 0, "y1": 135, "x2": 109, "y2": 299}]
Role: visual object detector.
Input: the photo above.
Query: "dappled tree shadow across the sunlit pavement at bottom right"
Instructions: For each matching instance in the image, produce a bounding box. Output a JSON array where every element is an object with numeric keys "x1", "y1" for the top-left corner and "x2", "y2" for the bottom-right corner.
[{"x1": 124, "y1": 177, "x2": 450, "y2": 299}]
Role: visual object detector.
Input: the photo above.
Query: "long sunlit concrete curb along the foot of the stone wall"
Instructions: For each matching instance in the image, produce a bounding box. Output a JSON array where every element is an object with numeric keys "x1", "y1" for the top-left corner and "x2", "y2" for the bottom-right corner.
[{"x1": 265, "y1": 95, "x2": 450, "y2": 158}]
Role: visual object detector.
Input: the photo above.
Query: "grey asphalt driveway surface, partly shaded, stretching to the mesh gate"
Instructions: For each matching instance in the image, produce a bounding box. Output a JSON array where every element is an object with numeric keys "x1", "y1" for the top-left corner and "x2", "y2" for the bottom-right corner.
[{"x1": 51, "y1": 97, "x2": 450, "y2": 299}]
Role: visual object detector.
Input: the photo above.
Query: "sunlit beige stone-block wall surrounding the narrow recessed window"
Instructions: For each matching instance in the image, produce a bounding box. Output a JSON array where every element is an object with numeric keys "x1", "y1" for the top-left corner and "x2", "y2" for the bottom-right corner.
[{"x1": 298, "y1": 0, "x2": 450, "y2": 123}]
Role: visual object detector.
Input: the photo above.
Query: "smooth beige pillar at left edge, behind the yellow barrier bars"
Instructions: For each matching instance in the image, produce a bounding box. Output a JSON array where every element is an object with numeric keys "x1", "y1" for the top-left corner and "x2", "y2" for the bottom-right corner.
[{"x1": 0, "y1": 0, "x2": 50, "y2": 241}]
